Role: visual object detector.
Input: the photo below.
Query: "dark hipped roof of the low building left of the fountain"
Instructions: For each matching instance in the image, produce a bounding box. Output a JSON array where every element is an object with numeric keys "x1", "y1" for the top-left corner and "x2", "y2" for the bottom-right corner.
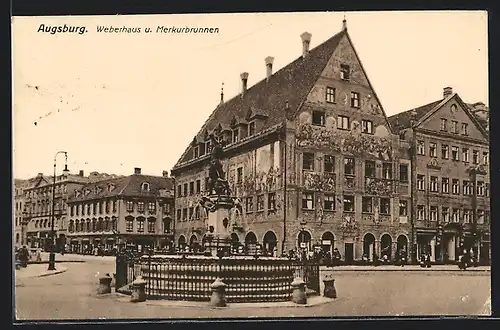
[{"x1": 69, "y1": 174, "x2": 173, "y2": 202}]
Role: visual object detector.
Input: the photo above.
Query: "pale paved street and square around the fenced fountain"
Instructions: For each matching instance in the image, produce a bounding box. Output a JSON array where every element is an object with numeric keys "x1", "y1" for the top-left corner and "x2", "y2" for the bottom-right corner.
[{"x1": 16, "y1": 257, "x2": 490, "y2": 320}]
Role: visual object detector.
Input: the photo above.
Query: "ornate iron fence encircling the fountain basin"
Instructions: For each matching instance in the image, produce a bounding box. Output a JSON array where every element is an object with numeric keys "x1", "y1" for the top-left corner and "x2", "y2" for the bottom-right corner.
[{"x1": 116, "y1": 255, "x2": 319, "y2": 302}]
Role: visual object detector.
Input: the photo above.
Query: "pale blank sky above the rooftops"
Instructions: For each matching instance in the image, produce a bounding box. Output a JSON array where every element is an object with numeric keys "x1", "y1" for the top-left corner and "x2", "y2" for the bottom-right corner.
[{"x1": 12, "y1": 12, "x2": 488, "y2": 178}]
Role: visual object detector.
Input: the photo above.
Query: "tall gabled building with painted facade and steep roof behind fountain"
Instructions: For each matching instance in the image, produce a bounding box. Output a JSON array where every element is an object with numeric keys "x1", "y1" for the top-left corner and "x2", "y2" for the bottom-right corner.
[{"x1": 172, "y1": 21, "x2": 411, "y2": 262}]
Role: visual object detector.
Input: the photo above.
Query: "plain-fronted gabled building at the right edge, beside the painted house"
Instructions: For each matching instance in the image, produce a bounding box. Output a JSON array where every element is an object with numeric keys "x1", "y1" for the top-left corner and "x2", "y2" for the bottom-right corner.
[{"x1": 390, "y1": 87, "x2": 491, "y2": 263}]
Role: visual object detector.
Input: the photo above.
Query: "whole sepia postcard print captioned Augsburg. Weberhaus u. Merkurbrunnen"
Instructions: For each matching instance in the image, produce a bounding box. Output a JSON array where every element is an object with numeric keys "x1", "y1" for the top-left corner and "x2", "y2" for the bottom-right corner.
[{"x1": 11, "y1": 11, "x2": 491, "y2": 322}]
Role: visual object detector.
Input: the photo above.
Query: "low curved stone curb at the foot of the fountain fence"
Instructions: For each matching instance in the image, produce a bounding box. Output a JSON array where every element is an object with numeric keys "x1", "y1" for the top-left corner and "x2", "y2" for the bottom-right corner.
[{"x1": 106, "y1": 292, "x2": 337, "y2": 309}]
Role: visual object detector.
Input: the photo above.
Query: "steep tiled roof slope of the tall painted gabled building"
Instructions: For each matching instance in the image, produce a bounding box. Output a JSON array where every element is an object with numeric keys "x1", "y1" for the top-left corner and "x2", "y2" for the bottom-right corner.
[{"x1": 176, "y1": 30, "x2": 346, "y2": 166}]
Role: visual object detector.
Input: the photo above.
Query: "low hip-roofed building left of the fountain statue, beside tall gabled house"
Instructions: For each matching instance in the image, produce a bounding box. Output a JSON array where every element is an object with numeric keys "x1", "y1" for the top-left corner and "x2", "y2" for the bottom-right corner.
[{"x1": 67, "y1": 168, "x2": 173, "y2": 253}]
